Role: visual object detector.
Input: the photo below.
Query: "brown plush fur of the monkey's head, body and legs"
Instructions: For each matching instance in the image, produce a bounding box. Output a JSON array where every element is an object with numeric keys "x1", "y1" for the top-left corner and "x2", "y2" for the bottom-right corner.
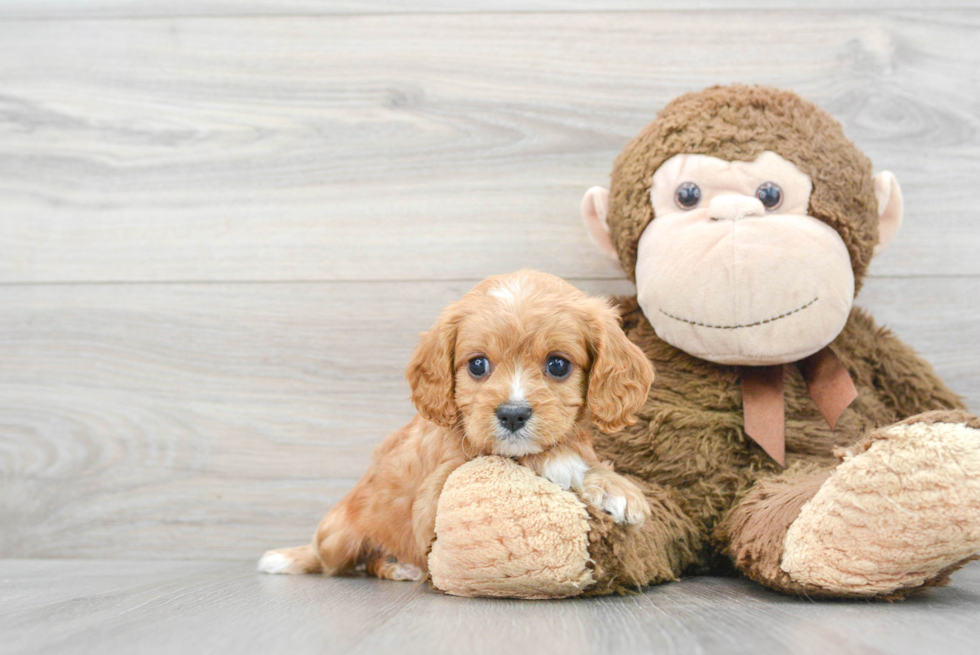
[{"x1": 572, "y1": 86, "x2": 976, "y2": 599}]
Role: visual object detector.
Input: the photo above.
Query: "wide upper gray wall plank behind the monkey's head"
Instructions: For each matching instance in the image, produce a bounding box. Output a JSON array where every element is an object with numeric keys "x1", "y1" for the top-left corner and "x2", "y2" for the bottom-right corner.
[{"x1": 0, "y1": 10, "x2": 980, "y2": 283}]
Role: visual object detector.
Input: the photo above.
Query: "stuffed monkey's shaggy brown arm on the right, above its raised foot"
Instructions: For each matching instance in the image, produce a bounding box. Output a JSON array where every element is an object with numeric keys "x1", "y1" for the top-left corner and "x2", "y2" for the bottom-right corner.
[{"x1": 849, "y1": 308, "x2": 965, "y2": 418}]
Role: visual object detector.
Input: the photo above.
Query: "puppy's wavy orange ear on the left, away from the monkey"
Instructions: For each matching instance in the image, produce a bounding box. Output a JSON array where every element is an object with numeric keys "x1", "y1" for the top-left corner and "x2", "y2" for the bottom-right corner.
[{"x1": 405, "y1": 306, "x2": 459, "y2": 428}]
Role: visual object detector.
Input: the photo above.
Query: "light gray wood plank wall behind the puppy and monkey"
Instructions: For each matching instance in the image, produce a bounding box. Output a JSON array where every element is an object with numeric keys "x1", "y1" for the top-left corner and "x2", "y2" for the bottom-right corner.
[{"x1": 0, "y1": 0, "x2": 980, "y2": 559}]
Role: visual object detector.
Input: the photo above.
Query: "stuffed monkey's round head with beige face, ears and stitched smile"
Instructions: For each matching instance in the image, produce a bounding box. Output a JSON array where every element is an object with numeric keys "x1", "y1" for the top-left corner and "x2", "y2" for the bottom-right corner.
[{"x1": 582, "y1": 86, "x2": 902, "y2": 365}]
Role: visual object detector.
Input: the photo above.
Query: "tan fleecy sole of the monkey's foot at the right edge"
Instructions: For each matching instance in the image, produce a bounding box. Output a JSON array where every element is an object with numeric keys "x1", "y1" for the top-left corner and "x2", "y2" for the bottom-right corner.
[{"x1": 781, "y1": 422, "x2": 980, "y2": 596}]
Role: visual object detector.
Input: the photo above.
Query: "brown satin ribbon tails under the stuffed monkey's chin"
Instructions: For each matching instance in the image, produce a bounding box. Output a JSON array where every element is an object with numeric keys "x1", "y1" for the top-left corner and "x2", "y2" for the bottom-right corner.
[{"x1": 742, "y1": 346, "x2": 857, "y2": 466}]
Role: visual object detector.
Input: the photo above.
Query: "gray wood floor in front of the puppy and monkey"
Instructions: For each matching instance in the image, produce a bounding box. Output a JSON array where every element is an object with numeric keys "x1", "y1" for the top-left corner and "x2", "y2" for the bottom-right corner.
[{"x1": 0, "y1": 560, "x2": 980, "y2": 655}]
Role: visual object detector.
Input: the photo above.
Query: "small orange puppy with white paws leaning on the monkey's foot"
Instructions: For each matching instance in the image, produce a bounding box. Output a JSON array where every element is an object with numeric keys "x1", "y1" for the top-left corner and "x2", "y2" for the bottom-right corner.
[{"x1": 259, "y1": 271, "x2": 653, "y2": 580}]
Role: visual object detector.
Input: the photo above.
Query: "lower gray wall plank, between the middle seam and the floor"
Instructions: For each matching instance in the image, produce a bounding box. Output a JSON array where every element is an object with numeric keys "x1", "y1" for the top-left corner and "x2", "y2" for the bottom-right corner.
[{"x1": 0, "y1": 277, "x2": 980, "y2": 559}]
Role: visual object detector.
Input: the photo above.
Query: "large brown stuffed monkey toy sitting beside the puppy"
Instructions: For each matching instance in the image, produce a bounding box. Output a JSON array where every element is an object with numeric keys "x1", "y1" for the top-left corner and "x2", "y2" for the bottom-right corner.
[{"x1": 429, "y1": 86, "x2": 980, "y2": 599}]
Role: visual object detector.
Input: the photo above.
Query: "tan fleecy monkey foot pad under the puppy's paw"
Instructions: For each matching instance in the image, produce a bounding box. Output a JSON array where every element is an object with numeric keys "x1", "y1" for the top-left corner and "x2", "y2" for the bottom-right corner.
[{"x1": 429, "y1": 457, "x2": 593, "y2": 598}]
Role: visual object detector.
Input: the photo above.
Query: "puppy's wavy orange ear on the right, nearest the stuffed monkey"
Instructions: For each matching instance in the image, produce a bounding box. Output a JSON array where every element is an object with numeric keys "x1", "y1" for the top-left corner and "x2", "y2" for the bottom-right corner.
[{"x1": 588, "y1": 299, "x2": 653, "y2": 432}]
